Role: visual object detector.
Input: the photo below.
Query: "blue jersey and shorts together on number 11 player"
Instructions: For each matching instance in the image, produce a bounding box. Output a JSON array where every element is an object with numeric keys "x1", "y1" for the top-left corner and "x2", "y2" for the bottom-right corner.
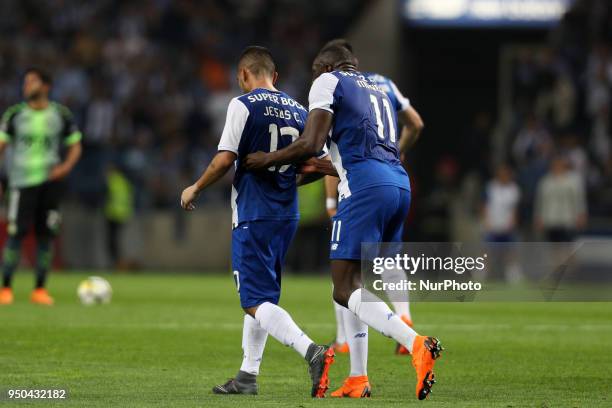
[{"x1": 309, "y1": 71, "x2": 410, "y2": 259}]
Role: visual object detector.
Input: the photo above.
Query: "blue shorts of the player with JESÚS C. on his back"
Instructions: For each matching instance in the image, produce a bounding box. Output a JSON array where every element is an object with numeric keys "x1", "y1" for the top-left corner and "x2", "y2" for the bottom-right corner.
[{"x1": 232, "y1": 220, "x2": 298, "y2": 308}]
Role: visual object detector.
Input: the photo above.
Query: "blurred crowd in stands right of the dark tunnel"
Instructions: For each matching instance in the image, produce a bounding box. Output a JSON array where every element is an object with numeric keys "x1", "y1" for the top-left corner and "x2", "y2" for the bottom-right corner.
[{"x1": 472, "y1": 0, "x2": 612, "y2": 241}]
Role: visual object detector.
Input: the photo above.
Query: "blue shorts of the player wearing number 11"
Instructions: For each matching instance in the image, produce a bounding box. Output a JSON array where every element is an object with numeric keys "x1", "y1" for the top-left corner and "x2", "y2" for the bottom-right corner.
[{"x1": 330, "y1": 186, "x2": 410, "y2": 259}]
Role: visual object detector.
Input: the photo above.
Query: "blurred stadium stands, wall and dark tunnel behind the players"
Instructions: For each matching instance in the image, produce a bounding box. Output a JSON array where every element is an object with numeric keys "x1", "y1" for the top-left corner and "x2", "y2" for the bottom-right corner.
[{"x1": 0, "y1": 0, "x2": 612, "y2": 272}]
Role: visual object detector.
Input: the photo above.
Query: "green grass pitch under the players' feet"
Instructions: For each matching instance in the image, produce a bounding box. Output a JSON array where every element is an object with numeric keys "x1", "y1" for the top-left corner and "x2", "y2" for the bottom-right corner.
[{"x1": 0, "y1": 272, "x2": 612, "y2": 408}]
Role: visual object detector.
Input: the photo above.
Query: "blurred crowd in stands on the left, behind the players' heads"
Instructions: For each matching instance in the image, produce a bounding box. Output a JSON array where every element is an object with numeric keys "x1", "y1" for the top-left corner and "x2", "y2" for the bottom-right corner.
[{"x1": 0, "y1": 0, "x2": 365, "y2": 217}]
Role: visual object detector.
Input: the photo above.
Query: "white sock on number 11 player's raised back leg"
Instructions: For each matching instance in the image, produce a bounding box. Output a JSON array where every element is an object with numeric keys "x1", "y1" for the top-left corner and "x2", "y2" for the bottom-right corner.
[{"x1": 348, "y1": 289, "x2": 417, "y2": 351}]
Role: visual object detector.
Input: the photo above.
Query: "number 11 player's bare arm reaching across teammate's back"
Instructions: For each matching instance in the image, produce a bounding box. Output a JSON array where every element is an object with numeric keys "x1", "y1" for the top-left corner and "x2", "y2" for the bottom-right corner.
[{"x1": 244, "y1": 109, "x2": 333, "y2": 170}]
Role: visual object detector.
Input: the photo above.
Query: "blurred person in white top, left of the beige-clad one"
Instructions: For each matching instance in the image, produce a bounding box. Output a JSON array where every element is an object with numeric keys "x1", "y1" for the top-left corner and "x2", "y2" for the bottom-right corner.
[{"x1": 482, "y1": 164, "x2": 521, "y2": 242}]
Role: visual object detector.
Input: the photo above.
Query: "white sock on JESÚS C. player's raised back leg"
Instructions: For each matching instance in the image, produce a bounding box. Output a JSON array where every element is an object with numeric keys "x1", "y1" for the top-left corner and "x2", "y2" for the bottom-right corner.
[{"x1": 255, "y1": 302, "x2": 313, "y2": 357}]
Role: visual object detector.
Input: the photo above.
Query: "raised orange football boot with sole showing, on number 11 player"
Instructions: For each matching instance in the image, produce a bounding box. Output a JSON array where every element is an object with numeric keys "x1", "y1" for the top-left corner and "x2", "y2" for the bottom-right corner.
[{"x1": 412, "y1": 336, "x2": 444, "y2": 400}]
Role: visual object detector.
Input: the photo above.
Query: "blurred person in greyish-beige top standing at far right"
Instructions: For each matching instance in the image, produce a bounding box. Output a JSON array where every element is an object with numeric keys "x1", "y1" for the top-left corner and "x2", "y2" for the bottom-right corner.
[{"x1": 535, "y1": 156, "x2": 587, "y2": 242}]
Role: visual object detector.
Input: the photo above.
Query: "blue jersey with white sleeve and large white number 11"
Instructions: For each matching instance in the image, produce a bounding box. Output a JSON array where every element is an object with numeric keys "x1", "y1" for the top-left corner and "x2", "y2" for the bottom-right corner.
[{"x1": 308, "y1": 71, "x2": 410, "y2": 200}]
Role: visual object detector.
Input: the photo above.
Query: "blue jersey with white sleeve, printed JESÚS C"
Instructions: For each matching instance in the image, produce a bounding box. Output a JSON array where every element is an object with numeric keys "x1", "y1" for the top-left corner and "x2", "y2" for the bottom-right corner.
[{"x1": 218, "y1": 88, "x2": 308, "y2": 228}]
